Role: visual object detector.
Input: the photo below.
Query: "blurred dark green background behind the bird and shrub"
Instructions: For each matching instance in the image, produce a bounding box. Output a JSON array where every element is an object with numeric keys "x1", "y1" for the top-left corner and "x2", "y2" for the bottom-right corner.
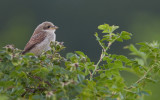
[{"x1": 0, "y1": 0, "x2": 160, "y2": 100}]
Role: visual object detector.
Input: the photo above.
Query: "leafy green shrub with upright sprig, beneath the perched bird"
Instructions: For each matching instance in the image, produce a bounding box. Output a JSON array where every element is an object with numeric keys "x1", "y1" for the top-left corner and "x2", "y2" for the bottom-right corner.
[{"x1": 0, "y1": 24, "x2": 160, "y2": 100}]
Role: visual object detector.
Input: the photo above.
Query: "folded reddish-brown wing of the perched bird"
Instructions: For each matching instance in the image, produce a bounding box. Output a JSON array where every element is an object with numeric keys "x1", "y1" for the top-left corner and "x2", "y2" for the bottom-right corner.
[{"x1": 22, "y1": 31, "x2": 47, "y2": 54}]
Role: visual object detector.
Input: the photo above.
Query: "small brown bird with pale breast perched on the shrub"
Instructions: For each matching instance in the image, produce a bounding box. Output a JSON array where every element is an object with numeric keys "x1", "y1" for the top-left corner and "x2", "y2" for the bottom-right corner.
[{"x1": 22, "y1": 21, "x2": 58, "y2": 56}]
